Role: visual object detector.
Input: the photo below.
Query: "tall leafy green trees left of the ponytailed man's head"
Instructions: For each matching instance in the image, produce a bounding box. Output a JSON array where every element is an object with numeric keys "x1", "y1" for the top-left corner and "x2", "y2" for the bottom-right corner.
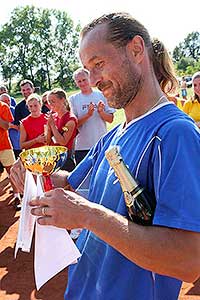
[{"x1": 0, "y1": 6, "x2": 80, "y2": 91}]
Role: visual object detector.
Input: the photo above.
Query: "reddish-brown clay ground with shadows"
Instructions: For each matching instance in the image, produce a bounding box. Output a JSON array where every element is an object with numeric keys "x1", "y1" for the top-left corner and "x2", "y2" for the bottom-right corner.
[{"x1": 0, "y1": 174, "x2": 200, "y2": 300}]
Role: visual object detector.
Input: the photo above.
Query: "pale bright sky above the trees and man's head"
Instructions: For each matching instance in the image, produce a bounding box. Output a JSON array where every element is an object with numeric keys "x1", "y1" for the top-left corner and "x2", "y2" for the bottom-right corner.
[{"x1": 0, "y1": 0, "x2": 200, "y2": 51}]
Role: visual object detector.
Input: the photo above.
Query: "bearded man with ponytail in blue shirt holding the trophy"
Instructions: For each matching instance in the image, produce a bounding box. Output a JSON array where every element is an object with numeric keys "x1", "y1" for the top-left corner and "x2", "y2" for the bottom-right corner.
[{"x1": 10, "y1": 13, "x2": 200, "y2": 300}]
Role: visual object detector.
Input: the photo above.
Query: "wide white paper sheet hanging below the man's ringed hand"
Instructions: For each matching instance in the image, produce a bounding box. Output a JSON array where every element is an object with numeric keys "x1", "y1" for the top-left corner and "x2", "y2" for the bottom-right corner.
[{"x1": 34, "y1": 223, "x2": 80, "y2": 290}]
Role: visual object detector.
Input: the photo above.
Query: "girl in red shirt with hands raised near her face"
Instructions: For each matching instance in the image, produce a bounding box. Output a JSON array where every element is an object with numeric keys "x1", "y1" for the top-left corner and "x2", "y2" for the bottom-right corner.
[{"x1": 47, "y1": 88, "x2": 78, "y2": 171}]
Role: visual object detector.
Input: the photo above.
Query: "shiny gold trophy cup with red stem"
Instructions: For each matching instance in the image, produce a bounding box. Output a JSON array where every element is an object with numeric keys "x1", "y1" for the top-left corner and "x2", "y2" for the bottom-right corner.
[{"x1": 20, "y1": 146, "x2": 67, "y2": 192}]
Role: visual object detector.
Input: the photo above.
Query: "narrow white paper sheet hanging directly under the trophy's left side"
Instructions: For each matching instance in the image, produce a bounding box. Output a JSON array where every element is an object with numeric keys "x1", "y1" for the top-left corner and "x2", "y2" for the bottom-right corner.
[{"x1": 15, "y1": 170, "x2": 37, "y2": 258}]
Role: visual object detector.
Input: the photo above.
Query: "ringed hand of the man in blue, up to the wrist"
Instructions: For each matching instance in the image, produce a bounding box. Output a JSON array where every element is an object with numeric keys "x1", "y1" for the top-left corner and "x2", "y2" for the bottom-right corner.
[{"x1": 29, "y1": 188, "x2": 91, "y2": 229}]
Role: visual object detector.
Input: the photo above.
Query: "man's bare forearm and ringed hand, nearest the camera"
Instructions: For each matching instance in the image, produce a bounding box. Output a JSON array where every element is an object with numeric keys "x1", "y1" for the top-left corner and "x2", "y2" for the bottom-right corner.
[{"x1": 31, "y1": 189, "x2": 200, "y2": 282}]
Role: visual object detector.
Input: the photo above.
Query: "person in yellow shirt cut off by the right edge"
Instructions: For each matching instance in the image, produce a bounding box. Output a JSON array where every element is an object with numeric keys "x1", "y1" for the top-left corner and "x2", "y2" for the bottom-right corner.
[{"x1": 183, "y1": 72, "x2": 200, "y2": 128}]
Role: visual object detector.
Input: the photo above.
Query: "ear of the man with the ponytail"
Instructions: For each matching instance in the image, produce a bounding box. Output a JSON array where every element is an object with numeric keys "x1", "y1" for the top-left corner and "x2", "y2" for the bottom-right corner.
[{"x1": 127, "y1": 35, "x2": 145, "y2": 64}]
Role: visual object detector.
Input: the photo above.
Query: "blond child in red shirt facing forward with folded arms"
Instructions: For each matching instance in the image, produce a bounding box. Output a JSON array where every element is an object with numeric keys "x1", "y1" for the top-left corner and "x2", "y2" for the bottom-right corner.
[{"x1": 20, "y1": 94, "x2": 47, "y2": 149}]
